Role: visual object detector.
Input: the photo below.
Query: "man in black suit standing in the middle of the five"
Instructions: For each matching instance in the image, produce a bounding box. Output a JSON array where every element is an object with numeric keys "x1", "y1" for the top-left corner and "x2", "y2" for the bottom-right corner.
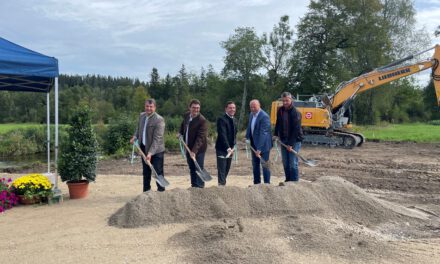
[{"x1": 215, "y1": 101, "x2": 237, "y2": 186}]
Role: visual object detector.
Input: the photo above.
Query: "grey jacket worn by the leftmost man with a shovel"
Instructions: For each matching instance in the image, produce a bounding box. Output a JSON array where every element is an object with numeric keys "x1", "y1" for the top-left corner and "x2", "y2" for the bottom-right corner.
[{"x1": 134, "y1": 112, "x2": 165, "y2": 155}]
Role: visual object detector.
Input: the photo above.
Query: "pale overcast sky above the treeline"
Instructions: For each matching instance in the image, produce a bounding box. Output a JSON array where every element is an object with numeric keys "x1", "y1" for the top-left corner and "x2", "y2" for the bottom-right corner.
[{"x1": 0, "y1": 0, "x2": 440, "y2": 81}]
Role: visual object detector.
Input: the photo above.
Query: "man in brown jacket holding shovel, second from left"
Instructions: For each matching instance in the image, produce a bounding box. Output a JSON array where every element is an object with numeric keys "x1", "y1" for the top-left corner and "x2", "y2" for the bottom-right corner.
[{"x1": 179, "y1": 99, "x2": 208, "y2": 188}]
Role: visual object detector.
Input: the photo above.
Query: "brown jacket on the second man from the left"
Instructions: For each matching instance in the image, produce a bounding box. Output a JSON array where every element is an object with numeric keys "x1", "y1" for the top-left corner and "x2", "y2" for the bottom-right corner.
[{"x1": 179, "y1": 112, "x2": 208, "y2": 154}]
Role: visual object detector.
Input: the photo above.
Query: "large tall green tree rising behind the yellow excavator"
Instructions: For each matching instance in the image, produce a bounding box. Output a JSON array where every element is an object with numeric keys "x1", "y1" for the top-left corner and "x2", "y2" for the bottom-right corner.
[{"x1": 290, "y1": 0, "x2": 424, "y2": 124}]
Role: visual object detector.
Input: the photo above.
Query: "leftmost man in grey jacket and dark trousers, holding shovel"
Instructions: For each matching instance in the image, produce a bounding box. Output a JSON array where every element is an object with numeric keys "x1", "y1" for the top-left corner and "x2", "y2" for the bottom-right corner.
[{"x1": 130, "y1": 99, "x2": 165, "y2": 192}]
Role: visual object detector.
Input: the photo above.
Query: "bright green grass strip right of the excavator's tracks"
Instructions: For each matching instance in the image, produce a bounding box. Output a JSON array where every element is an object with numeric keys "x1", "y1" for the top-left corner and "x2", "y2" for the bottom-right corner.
[{"x1": 354, "y1": 123, "x2": 440, "y2": 143}]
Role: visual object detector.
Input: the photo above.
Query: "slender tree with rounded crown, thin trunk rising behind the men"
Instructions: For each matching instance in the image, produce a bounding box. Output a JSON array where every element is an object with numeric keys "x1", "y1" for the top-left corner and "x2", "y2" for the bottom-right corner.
[{"x1": 221, "y1": 27, "x2": 264, "y2": 129}]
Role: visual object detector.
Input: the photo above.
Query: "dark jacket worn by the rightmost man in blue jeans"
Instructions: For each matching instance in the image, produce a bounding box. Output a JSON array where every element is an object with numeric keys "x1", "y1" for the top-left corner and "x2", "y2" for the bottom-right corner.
[{"x1": 274, "y1": 107, "x2": 303, "y2": 146}]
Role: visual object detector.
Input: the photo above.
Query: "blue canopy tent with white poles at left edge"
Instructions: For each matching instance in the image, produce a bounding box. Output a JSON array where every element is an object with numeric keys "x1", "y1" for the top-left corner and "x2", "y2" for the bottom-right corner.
[{"x1": 0, "y1": 37, "x2": 59, "y2": 192}]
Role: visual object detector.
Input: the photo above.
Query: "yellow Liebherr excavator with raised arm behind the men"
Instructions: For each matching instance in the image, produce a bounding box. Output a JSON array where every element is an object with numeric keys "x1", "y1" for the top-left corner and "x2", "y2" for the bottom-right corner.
[{"x1": 271, "y1": 45, "x2": 440, "y2": 148}]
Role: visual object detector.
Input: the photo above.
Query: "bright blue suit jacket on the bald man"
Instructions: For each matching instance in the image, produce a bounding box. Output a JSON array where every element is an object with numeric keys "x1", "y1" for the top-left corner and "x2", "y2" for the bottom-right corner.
[{"x1": 246, "y1": 109, "x2": 272, "y2": 152}]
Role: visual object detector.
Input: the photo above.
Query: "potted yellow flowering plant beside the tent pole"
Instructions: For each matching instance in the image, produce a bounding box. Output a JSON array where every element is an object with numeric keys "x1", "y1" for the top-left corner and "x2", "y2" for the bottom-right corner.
[{"x1": 12, "y1": 173, "x2": 53, "y2": 204}]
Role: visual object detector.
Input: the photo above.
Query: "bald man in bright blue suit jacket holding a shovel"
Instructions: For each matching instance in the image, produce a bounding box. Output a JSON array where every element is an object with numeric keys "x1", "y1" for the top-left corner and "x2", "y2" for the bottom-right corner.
[{"x1": 246, "y1": 99, "x2": 272, "y2": 184}]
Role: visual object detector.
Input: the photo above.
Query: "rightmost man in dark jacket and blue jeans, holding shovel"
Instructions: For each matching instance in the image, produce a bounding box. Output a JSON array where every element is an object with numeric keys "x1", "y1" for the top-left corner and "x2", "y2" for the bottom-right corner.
[{"x1": 275, "y1": 92, "x2": 302, "y2": 182}]
